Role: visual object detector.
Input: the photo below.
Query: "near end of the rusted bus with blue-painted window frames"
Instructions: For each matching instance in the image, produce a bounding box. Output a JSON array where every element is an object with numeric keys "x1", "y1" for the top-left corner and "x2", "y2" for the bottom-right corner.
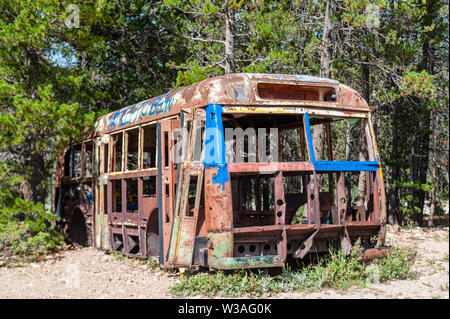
[{"x1": 164, "y1": 80, "x2": 385, "y2": 269}]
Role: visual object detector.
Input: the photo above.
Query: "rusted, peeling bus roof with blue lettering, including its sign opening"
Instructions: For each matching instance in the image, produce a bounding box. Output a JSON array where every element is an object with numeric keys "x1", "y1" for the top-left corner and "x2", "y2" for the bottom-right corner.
[{"x1": 95, "y1": 73, "x2": 370, "y2": 134}]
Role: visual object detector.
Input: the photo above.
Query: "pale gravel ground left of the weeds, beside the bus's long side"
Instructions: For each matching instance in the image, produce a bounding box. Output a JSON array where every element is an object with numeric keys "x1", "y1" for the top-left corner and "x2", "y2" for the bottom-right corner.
[{"x1": 0, "y1": 247, "x2": 178, "y2": 299}]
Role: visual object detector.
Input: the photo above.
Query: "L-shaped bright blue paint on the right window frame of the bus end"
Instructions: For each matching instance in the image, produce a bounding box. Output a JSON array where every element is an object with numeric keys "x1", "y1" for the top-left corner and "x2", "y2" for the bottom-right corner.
[{"x1": 305, "y1": 112, "x2": 380, "y2": 171}]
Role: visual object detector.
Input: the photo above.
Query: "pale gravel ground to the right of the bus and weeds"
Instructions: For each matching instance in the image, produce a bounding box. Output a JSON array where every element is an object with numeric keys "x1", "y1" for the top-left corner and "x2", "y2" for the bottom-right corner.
[{"x1": 274, "y1": 226, "x2": 449, "y2": 299}]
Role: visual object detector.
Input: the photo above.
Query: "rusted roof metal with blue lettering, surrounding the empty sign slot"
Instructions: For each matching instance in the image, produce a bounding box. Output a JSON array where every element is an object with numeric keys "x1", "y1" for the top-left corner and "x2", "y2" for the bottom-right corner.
[{"x1": 95, "y1": 73, "x2": 369, "y2": 134}]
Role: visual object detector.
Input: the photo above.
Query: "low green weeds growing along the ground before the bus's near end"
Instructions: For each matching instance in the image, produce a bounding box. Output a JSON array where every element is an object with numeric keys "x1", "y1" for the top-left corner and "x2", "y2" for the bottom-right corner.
[{"x1": 169, "y1": 243, "x2": 415, "y2": 297}]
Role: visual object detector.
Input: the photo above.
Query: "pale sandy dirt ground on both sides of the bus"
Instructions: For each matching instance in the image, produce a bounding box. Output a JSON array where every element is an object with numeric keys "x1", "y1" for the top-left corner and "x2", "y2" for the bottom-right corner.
[{"x1": 0, "y1": 226, "x2": 449, "y2": 299}]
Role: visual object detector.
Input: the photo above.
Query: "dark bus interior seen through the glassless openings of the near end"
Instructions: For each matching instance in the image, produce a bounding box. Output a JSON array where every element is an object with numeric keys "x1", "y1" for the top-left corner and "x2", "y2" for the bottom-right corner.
[{"x1": 223, "y1": 114, "x2": 369, "y2": 227}]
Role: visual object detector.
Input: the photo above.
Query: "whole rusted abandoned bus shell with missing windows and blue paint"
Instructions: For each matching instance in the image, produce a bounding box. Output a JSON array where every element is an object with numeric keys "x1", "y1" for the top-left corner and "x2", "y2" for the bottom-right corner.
[{"x1": 54, "y1": 74, "x2": 386, "y2": 269}]
